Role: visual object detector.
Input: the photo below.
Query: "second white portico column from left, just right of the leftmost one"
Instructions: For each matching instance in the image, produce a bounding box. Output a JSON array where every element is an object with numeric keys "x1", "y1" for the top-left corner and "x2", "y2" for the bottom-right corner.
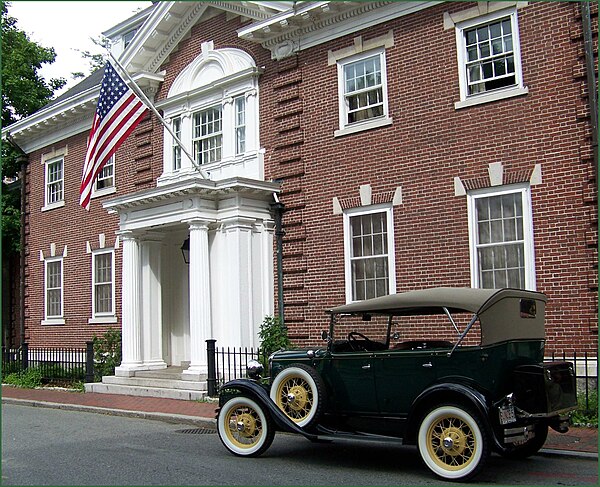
[{"x1": 140, "y1": 235, "x2": 167, "y2": 369}]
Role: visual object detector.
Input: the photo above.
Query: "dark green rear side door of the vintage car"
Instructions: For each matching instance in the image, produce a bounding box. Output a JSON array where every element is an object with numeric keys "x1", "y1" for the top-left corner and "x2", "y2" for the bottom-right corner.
[{"x1": 372, "y1": 349, "x2": 436, "y2": 416}]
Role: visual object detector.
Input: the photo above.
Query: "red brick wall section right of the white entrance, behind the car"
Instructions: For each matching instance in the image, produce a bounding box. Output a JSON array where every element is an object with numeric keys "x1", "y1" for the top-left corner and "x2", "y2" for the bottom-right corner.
[{"x1": 261, "y1": 2, "x2": 597, "y2": 350}]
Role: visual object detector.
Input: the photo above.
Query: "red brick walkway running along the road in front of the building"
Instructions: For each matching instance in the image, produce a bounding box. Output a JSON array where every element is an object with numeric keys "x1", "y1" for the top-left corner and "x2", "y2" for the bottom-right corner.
[{"x1": 2, "y1": 386, "x2": 598, "y2": 454}]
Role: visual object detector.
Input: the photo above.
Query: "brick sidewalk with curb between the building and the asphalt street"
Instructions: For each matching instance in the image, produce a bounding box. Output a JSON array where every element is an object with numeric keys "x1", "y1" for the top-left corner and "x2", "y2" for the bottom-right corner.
[{"x1": 2, "y1": 386, "x2": 598, "y2": 458}]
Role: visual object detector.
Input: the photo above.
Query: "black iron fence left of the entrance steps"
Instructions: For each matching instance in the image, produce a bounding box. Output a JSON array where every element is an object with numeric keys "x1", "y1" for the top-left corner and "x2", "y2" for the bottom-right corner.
[{"x1": 2, "y1": 342, "x2": 94, "y2": 383}]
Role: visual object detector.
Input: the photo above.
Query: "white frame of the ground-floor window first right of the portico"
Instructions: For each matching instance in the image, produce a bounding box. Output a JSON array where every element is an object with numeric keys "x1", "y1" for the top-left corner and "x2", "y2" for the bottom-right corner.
[{"x1": 343, "y1": 204, "x2": 396, "y2": 303}]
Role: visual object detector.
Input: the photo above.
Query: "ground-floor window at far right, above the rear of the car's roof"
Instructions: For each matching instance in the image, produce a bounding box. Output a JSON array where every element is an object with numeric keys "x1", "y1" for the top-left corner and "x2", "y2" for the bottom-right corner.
[{"x1": 469, "y1": 187, "x2": 535, "y2": 290}]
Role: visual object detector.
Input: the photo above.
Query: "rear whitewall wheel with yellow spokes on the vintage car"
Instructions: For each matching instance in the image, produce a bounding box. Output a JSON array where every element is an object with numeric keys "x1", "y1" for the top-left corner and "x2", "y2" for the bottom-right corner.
[{"x1": 418, "y1": 405, "x2": 490, "y2": 480}]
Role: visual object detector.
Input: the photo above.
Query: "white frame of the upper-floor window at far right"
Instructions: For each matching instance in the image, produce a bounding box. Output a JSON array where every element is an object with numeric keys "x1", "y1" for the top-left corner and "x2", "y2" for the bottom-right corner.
[{"x1": 454, "y1": 7, "x2": 529, "y2": 109}]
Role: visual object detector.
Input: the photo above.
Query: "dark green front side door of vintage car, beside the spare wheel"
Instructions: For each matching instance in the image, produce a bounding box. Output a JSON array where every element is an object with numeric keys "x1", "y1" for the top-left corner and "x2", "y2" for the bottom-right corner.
[{"x1": 323, "y1": 351, "x2": 379, "y2": 416}]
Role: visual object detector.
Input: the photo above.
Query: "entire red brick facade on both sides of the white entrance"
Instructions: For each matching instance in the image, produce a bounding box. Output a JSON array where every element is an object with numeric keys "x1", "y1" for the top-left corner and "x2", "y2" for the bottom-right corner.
[{"x1": 27, "y1": 2, "x2": 597, "y2": 356}]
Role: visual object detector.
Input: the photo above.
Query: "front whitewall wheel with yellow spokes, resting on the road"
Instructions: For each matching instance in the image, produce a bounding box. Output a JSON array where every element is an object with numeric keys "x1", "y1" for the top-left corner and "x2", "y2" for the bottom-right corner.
[{"x1": 217, "y1": 397, "x2": 275, "y2": 457}]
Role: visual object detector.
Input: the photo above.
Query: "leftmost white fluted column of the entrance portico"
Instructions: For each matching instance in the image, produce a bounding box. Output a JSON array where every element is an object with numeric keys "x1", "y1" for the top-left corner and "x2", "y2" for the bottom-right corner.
[{"x1": 115, "y1": 232, "x2": 142, "y2": 377}]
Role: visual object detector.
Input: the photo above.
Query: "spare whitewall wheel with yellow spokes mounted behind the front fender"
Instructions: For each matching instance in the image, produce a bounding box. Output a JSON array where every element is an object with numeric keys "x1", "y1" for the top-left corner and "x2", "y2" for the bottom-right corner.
[{"x1": 270, "y1": 364, "x2": 324, "y2": 428}]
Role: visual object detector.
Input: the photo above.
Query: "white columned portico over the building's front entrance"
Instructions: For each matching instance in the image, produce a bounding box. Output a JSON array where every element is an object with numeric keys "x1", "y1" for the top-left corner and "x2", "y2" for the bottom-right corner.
[{"x1": 105, "y1": 177, "x2": 278, "y2": 381}]
